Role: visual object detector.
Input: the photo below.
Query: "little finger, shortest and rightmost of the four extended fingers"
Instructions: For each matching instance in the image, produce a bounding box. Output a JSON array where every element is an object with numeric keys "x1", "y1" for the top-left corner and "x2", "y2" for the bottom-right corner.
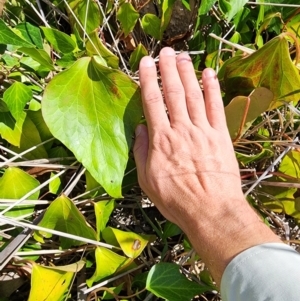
[{"x1": 202, "y1": 68, "x2": 227, "y2": 130}]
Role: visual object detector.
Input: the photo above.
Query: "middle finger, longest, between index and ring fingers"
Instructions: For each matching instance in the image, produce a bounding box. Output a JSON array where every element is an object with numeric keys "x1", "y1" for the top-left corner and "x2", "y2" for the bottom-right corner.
[{"x1": 159, "y1": 47, "x2": 189, "y2": 124}]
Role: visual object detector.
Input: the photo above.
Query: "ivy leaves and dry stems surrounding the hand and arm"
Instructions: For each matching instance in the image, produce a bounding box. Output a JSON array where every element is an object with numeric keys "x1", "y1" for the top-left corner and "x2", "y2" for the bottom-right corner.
[{"x1": 0, "y1": 0, "x2": 300, "y2": 301}]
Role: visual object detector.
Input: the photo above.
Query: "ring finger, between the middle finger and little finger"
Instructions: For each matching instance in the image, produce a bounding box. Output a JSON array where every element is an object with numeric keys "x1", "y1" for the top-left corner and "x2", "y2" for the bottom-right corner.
[{"x1": 176, "y1": 53, "x2": 207, "y2": 126}]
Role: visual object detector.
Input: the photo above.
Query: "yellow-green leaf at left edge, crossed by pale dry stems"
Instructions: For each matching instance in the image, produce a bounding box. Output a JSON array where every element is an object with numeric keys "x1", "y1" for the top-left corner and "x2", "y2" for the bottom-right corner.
[{"x1": 0, "y1": 167, "x2": 40, "y2": 217}]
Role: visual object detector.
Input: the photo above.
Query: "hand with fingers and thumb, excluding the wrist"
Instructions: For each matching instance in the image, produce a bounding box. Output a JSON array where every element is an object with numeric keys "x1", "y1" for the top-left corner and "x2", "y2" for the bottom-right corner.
[{"x1": 134, "y1": 48, "x2": 243, "y2": 229}]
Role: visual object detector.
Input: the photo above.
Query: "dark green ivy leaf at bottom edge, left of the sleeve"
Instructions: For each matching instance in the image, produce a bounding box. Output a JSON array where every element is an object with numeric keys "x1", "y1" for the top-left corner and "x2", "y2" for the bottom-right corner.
[{"x1": 146, "y1": 263, "x2": 211, "y2": 301}]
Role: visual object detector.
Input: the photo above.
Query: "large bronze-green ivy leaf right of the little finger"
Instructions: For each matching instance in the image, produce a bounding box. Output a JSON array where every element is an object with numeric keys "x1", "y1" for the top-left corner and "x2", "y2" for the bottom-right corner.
[{"x1": 220, "y1": 34, "x2": 300, "y2": 109}]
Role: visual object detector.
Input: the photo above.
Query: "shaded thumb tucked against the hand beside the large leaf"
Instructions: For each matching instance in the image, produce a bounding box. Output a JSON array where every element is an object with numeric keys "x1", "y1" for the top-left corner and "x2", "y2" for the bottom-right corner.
[{"x1": 133, "y1": 124, "x2": 149, "y2": 181}]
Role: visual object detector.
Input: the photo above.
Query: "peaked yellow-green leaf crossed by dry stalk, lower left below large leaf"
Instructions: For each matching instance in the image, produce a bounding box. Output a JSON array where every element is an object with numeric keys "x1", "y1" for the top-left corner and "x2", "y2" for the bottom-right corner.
[{"x1": 34, "y1": 195, "x2": 97, "y2": 249}]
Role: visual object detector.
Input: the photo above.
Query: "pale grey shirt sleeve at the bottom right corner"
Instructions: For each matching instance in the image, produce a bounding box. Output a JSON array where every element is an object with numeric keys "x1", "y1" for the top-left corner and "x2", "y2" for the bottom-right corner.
[{"x1": 221, "y1": 243, "x2": 300, "y2": 301}]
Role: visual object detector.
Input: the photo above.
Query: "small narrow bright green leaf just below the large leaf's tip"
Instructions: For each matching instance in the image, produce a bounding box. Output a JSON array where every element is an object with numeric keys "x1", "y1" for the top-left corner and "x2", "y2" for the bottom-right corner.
[{"x1": 94, "y1": 200, "x2": 115, "y2": 239}]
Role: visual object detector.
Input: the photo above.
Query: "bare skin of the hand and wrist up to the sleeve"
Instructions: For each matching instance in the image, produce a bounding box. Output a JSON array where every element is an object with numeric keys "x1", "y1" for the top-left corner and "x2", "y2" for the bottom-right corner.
[{"x1": 134, "y1": 47, "x2": 281, "y2": 285}]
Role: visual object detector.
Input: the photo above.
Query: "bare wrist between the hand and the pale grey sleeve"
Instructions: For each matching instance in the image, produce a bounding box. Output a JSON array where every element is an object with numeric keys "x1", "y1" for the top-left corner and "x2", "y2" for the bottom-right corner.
[{"x1": 182, "y1": 198, "x2": 281, "y2": 284}]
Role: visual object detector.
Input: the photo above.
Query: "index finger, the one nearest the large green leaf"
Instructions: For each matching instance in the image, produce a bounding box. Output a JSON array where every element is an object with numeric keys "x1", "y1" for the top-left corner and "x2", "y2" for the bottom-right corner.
[{"x1": 140, "y1": 56, "x2": 170, "y2": 131}]
